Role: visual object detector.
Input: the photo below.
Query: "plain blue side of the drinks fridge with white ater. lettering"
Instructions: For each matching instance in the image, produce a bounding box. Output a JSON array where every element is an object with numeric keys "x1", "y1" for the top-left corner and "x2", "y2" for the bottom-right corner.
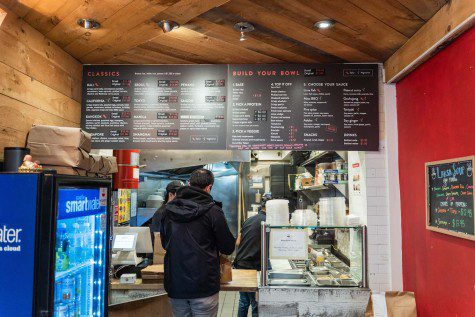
[{"x1": 0, "y1": 174, "x2": 40, "y2": 316}]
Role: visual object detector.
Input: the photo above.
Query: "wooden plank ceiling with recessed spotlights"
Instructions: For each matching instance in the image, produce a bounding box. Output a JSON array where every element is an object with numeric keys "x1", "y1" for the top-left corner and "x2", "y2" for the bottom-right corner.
[{"x1": 0, "y1": 0, "x2": 446, "y2": 64}]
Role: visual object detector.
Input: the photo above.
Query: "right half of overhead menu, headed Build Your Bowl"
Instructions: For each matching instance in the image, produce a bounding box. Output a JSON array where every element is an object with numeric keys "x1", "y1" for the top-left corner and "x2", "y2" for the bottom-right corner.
[{"x1": 228, "y1": 64, "x2": 379, "y2": 150}]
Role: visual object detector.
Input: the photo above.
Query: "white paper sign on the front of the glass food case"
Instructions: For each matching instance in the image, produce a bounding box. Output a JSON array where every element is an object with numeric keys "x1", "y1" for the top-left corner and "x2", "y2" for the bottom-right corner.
[{"x1": 269, "y1": 228, "x2": 308, "y2": 260}]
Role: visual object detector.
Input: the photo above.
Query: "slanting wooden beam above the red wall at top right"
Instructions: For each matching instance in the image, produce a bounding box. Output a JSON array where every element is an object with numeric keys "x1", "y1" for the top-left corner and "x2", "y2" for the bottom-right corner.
[{"x1": 384, "y1": 0, "x2": 475, "y2": 83}]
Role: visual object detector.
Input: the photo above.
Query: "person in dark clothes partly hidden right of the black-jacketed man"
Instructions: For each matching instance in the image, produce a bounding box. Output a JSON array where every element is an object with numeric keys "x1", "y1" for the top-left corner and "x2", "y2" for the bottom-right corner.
[{"x1": 234, "y1": 197, "x2": 270, "y2": 317}]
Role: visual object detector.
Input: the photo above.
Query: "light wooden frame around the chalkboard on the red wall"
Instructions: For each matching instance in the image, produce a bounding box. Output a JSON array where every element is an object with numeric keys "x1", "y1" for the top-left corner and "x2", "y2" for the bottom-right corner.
[{"x1": 424, "y1": 155, "x2": 475, "y2": 241}]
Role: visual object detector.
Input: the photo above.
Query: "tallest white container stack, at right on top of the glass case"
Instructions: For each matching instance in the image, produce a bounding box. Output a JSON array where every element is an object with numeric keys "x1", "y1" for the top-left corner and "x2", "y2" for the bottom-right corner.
[{"x1": 318, "y1": 197, "x2": 346, "y2": 226}]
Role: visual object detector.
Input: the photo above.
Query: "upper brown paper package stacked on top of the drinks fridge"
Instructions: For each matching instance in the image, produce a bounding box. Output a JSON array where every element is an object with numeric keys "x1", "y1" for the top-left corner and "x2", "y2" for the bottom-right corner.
[{"x1": 27, "y1": 125, "x2": 91, "y2": 153}]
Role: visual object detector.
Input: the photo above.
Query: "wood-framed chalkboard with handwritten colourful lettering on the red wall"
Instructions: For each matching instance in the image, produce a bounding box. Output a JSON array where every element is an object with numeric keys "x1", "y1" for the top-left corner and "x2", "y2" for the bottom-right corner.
[{"x1": 426, "y1": 156, "x2": 475, "y2": 240}]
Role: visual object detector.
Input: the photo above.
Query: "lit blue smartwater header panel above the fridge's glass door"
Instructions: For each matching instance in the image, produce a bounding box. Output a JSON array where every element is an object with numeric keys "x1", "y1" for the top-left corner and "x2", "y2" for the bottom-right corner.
[{"x1": 58, "y1": 188, "x2": 107, "y2": 219}]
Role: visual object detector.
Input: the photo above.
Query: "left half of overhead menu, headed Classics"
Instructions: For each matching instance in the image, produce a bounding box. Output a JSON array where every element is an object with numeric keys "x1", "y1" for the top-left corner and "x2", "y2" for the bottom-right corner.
[{"x1": 81, "y1": 65, "x2": 227, "y2": 149}]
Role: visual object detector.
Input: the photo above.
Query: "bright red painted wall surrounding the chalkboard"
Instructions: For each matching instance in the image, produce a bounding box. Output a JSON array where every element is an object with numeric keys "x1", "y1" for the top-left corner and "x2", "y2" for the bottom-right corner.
[{"x1": 396, "y1": 28, "x2": 475, "y2": 317}]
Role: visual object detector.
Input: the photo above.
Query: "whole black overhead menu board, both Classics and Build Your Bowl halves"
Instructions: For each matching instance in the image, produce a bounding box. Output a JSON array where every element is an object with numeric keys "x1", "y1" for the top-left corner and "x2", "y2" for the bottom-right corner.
[{"x1": 81, "y1": 64, "x2": 379, "y2": 151}]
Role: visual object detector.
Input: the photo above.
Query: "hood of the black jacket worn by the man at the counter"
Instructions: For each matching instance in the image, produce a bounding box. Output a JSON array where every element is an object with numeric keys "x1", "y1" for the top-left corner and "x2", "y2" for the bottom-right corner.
[{"x1": 166, "y1": 186, "x2": 216, "y2": 222}]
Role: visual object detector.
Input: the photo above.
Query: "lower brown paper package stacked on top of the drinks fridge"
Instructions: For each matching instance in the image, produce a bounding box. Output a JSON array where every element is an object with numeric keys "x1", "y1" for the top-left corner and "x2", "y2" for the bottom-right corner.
[{"x1": 27, "y1": 142, "x2": 91, "y2": 171}]
